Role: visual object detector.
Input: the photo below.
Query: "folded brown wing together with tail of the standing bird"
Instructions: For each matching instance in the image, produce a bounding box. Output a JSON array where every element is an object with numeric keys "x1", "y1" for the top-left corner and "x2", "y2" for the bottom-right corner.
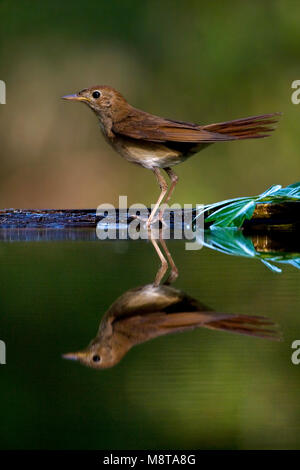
[{"x1": 112, "y1": 109, "x2": 280, "y2": 143}]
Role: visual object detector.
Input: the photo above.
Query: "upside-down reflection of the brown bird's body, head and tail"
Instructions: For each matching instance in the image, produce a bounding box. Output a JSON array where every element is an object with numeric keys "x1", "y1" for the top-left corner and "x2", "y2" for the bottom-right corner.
[{"x1": 63, "y1": 284, "x2": 279, "y2": 369}]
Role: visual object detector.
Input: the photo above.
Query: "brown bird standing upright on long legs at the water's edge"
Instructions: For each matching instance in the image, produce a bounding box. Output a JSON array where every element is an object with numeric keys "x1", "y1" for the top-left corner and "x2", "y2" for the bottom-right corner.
[{"x1": 63, "y1": 85, "x2": 280, "y2": 226}]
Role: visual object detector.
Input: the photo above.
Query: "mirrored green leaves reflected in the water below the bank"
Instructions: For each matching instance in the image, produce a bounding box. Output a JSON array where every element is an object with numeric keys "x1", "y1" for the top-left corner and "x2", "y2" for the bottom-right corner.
[{"x1": 204, "y1": 226, "x2": 300, "y2": 273}]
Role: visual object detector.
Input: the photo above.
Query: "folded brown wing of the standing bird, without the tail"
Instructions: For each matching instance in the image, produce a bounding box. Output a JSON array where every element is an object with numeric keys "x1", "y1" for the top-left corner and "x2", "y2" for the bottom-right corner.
[{"x1": 112, "y1": 111, "x2": 236, "y2": 143}]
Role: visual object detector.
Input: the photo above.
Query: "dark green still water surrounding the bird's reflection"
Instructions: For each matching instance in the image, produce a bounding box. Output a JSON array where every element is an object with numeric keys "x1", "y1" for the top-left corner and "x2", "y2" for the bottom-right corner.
[{"x1": 0, "y1": 231, "x2": 300, "y2": 449}]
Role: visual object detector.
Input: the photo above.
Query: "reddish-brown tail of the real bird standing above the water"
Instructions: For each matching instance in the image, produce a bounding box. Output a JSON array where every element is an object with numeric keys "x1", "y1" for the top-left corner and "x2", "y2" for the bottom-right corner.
[{"x1": 202, "y1": 113, "x2": 281, "y2": 140}]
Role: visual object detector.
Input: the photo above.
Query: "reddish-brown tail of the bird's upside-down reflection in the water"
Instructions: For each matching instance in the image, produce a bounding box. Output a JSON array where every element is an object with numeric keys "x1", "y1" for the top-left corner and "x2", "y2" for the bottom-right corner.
[{"x1": 203, "y1": 312, "x2": 281, "y2": 341}]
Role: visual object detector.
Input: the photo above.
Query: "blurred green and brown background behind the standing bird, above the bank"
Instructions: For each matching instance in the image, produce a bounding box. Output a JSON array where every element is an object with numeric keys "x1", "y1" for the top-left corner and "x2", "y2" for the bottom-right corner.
[{"x1": 0, "y1": 0, "x2": 300, "y2": 208}]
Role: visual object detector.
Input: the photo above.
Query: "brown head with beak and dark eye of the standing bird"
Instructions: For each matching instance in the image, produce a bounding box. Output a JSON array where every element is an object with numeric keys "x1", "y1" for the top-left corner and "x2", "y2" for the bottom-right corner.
[{"x1": 62, "y1": 85, "x2": 127, "y2": 118}]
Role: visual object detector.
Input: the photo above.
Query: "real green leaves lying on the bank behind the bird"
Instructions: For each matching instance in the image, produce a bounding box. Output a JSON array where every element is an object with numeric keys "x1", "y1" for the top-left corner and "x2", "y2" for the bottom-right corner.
[{"x1": 197, "y1": 182, "x2": 300, "y2": 229}]
